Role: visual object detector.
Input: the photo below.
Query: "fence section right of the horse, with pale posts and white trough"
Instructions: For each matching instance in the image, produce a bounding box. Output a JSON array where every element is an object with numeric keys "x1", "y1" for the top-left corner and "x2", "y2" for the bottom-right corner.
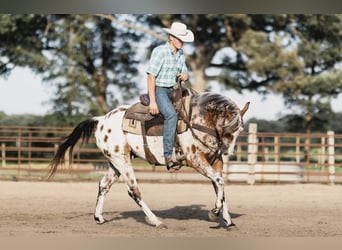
[{"x1": 225, "y1": 124, "x2": 342, "y2": 184}]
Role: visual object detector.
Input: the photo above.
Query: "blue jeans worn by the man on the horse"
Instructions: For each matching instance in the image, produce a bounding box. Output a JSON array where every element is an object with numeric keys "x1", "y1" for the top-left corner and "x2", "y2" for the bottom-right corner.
[{"x1": 156, "y1": 86, "x2": 178, "y2": 160}]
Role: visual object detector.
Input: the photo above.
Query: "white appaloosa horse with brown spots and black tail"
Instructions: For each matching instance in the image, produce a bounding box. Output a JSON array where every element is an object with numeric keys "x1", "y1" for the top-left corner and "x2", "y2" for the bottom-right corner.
[{"x1": 49, "y1": 92, "x2": 249, "y2": 228}]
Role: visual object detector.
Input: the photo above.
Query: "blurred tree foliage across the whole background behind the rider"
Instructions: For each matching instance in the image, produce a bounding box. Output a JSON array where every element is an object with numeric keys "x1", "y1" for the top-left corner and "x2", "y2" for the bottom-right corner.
[{"x1": 0, "y1": 14, "x2": 342, "y2": 132}]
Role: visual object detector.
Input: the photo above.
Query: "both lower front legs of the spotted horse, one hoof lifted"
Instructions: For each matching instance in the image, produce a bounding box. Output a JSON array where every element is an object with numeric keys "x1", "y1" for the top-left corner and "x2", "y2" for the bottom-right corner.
[{"x1": 206, "y1": 167, "x2": 235, "y2": 229}]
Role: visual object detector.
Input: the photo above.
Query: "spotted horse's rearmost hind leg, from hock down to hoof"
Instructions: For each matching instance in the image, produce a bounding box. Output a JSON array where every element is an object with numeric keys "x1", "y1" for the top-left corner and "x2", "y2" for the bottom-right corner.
[{"x1": 94, "y1": 162, "x2": 120, "y2": 224}]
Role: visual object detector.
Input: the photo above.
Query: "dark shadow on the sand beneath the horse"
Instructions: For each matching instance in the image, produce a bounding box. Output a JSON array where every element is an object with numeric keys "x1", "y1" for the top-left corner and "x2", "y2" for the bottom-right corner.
[{"x1": 104, "y1": 204, "x2": 244, "y2": 229}]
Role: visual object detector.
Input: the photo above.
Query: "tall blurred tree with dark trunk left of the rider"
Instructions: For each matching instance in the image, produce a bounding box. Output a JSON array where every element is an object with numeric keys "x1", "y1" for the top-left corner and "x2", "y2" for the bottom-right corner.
[{"x1": 45, "y1": 15, "x2": 141, "y2": 120}]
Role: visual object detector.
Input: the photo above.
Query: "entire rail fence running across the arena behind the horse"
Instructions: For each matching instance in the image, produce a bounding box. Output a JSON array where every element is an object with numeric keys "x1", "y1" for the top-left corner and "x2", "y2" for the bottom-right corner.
[{"x1": 0, "y1": 124, "x2": 342, "y2": 184}]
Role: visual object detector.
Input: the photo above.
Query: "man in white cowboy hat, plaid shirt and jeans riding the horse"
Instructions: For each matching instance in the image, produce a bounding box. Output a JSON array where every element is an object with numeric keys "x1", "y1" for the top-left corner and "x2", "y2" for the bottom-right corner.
[{"x1": 147, "y1": 22, "x2": 194, "y2": 170}]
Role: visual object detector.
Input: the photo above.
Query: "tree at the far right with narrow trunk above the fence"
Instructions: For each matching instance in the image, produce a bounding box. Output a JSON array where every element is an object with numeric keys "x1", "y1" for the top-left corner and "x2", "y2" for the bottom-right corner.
[{"x1": 284, "y1": 15, "x2": 342, "y2": 133}]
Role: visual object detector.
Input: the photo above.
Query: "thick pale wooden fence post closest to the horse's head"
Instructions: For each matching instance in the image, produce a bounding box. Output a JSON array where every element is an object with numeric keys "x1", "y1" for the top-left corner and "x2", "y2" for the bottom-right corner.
[{"x1": 247, "y1": 123, "x2": 258, "y2": 185}]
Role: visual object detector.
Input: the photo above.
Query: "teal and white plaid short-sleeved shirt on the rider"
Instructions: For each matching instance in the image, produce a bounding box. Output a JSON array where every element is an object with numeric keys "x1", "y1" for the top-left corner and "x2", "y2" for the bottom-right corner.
[{"x1": 147, "y1": 43, "x2": 188, "y2": 87}]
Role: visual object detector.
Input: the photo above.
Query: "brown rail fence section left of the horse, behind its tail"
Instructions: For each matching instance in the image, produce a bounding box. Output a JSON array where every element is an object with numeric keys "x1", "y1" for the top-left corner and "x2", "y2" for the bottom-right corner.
[{"x1": 0, "y1": 126, "x2": 111, "y2": 180}]
